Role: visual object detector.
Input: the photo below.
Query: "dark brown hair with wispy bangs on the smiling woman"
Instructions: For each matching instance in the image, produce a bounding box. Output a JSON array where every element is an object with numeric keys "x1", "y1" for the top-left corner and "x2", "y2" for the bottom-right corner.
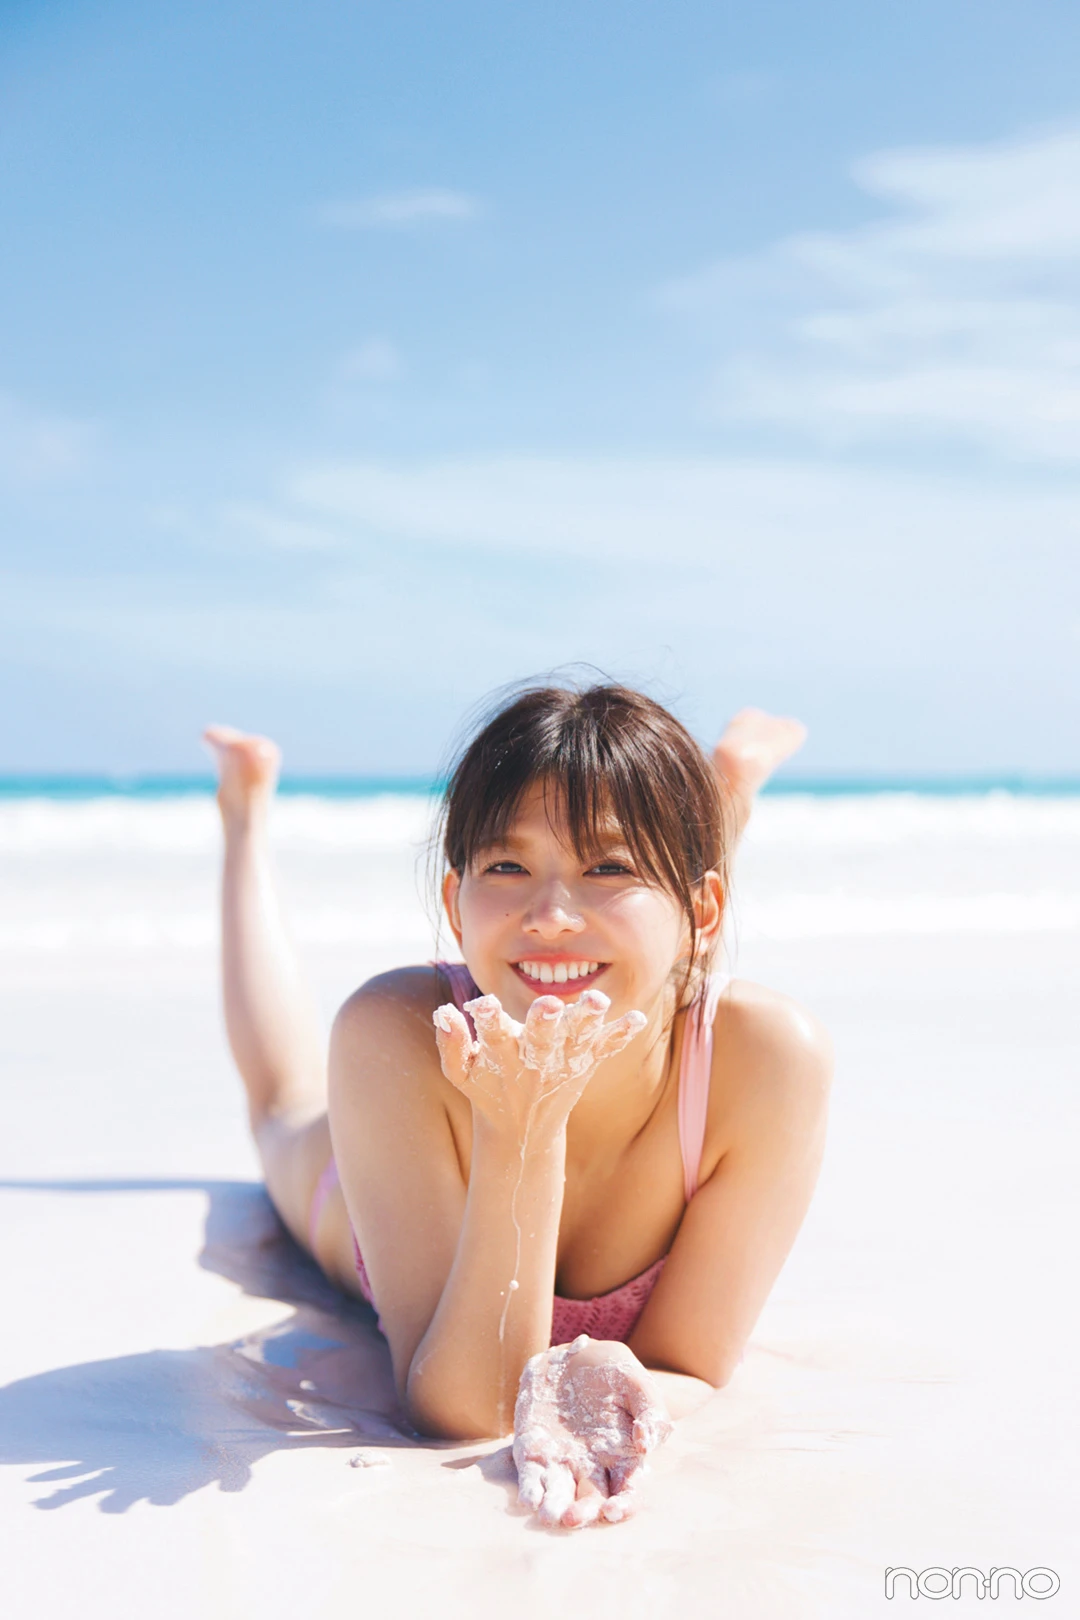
[{"x1": 442, "y1": 684, "x2": 727, "y2": 1001}]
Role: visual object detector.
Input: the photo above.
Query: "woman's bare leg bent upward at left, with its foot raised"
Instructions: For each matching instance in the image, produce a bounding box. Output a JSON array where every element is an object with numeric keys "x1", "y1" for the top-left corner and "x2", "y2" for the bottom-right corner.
[{"x1": 204, "y1": 726, "x2": 340, "y2": 1272}]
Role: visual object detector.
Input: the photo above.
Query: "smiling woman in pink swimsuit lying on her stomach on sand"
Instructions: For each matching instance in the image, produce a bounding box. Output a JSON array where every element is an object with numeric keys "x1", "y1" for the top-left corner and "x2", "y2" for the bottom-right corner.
[{"x1": 206, "y1": 685, "x2": 831, "y2": 1528}]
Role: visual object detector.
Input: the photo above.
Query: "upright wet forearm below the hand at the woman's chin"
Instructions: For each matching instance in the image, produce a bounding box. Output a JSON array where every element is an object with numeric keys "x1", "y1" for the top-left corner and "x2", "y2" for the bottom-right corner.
[{"x1": 406, "y1": 1121, "x2": 567, "y2": 1439}]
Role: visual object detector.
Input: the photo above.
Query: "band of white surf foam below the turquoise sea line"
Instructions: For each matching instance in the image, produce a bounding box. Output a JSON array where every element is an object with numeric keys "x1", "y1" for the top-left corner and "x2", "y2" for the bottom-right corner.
[{"x1": 0, "y1": 794, "x2": 1080, "y2": 961}]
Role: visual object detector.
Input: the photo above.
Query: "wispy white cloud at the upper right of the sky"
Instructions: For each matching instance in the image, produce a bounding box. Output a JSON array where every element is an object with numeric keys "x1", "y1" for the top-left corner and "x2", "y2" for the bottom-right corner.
[{"x1": 661, "y1": 130, "x2": 1080, "y2": 462}]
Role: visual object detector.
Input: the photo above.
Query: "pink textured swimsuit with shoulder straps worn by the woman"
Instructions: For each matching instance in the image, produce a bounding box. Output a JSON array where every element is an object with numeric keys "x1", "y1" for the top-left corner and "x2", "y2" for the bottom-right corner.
[{"x1": 308, "y1": 962, "x2": 727, "y2": 1345}]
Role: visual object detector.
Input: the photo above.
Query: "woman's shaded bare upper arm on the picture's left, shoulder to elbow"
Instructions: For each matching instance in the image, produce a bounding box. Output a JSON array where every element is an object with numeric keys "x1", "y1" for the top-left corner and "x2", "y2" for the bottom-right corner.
[{"x1": 329, "y1": 974, "x2": 466, "y2": 1388}]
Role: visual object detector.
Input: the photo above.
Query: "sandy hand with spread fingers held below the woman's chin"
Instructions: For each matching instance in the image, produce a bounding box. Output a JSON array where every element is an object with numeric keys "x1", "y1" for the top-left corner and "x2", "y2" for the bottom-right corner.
[{"x1": 434, "y1": 990, "x2": 646, "y2": 1142}]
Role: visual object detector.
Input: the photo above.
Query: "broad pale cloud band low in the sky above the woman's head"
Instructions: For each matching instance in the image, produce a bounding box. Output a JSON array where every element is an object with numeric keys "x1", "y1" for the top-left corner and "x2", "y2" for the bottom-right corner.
[{"x1": 19, "y1": 455, "x2": 1080, "y2": 712}]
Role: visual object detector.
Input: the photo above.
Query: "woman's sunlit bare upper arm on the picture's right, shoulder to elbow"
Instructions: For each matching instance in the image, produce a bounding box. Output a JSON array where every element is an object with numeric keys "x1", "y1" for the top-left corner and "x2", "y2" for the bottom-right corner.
[{"x1": 630, "y1": 996, "x2": 832, "y2": 1385}]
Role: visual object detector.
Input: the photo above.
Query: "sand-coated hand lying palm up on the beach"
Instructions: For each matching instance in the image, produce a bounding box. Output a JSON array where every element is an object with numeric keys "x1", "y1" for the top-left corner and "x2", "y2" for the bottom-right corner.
[{"x1": 513, "y1": 1333, "x2": 672, "y2": 1529}]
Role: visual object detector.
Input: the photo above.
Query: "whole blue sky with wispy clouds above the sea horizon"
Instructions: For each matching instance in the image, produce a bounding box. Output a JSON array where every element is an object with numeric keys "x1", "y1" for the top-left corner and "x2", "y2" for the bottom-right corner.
[{"x1": 0, "y1": 0, "x2": 1080, "y2": 771}]
